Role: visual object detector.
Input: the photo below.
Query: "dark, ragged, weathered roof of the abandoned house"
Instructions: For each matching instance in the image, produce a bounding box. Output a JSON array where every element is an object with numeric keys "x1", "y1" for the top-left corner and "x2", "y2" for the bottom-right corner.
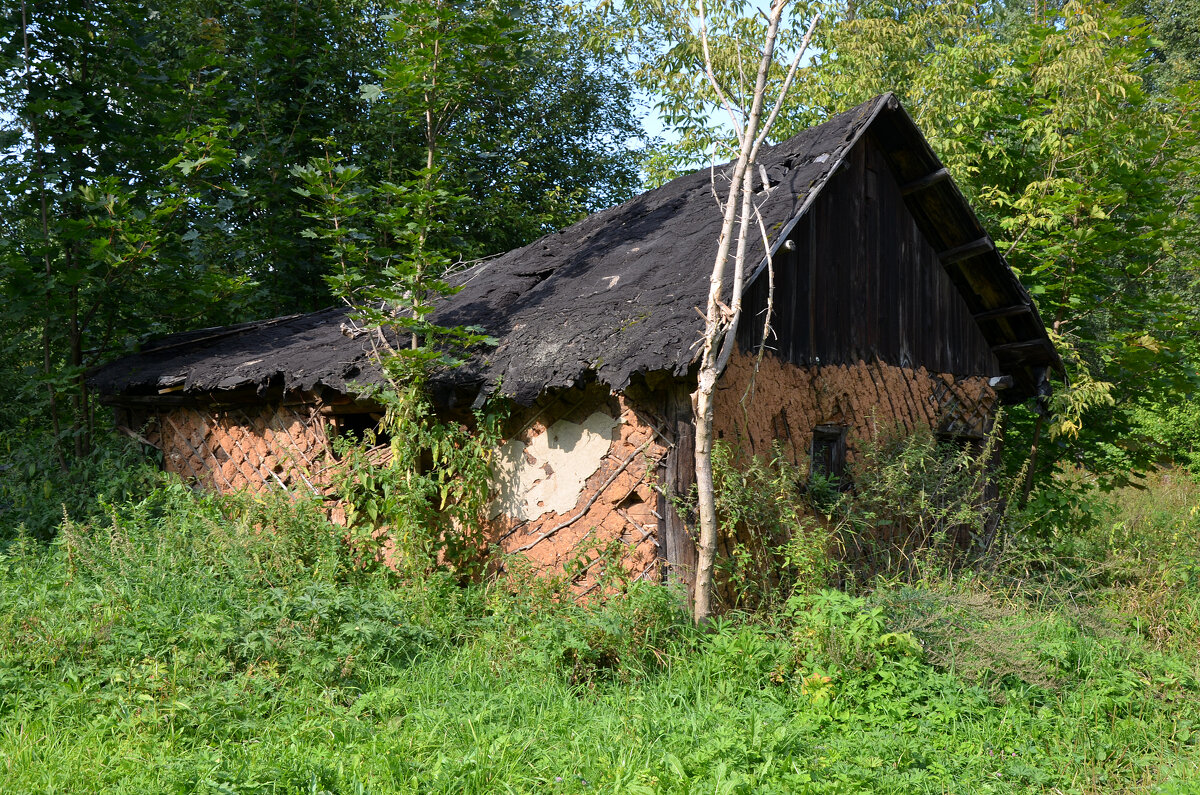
[{"x1": 91, "y1": 95, "x2": 1061, "y2": 404}]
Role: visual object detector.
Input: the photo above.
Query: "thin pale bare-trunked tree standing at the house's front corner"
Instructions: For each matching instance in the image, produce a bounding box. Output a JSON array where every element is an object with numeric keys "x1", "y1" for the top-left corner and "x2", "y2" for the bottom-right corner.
[{"x1": 692, "y1": 0, "x2": 820, "y2": 623}]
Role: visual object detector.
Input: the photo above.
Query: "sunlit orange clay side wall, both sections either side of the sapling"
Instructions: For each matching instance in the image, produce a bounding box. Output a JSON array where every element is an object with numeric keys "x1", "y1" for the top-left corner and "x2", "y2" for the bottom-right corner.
[{"x1": 125, "y1": 388, "x2": 668, "y2": 594}]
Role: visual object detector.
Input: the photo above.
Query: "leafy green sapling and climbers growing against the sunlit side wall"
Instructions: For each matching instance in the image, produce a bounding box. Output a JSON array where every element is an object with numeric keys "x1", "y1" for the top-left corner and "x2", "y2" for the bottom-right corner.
[{"x1": 293, "y1": 152, "x2": 505, "y2": 576}]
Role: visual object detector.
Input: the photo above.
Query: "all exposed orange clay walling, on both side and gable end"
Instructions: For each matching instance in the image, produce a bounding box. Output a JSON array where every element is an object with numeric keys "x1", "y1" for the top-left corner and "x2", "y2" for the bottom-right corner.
[{"x1": 124, "y1": 353, "x2": 996, "y2": 594}]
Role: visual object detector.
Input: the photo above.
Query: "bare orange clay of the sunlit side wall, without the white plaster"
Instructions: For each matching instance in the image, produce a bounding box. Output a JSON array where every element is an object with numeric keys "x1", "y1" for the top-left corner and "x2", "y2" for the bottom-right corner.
[{"x1": 144, "y1": 393, "x2": 667, "y2": 594}]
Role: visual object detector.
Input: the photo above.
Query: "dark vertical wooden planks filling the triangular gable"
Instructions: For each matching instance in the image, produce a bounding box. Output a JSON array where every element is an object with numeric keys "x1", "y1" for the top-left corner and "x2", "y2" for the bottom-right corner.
[{"x1": 739, "y1": 136, "x2": 998, "y2": 375}]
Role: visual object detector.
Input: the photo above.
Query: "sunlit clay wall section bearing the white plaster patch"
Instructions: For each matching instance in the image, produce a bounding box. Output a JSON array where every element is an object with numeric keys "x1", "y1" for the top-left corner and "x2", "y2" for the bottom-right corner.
[{"x1": 492, "y1": 388, "x2": 668, "y2": 596}]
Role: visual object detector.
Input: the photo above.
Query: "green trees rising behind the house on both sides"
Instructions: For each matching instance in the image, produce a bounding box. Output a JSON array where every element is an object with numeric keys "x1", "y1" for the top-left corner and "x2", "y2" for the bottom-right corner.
[{"x1": 0, "y1": 0, "x2": 1200, "y2": 492}]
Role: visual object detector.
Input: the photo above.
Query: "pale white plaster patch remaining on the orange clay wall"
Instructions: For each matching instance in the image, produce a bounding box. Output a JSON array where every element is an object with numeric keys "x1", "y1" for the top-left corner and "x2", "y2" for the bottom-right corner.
[{"x1": 488, "y1": 412, "x2": 617, "y2": 521}]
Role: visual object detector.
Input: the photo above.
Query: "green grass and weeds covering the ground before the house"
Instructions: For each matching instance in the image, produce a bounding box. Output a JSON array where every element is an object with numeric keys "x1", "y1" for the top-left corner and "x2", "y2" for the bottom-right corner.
[{"x1": 0, "y1": 475, "x2": 1200, "y2": 793}]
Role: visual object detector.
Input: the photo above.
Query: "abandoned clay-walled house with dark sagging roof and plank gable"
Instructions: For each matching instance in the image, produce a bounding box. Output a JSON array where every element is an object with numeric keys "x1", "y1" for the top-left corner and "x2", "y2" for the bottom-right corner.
[{"x1": 91, "y1": 95, "x2": 1062, "y2": 591}]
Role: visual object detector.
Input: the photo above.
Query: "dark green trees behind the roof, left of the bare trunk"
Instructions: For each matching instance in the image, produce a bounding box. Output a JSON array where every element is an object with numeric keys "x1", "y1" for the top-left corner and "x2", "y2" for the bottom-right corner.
[{"x1": 0, "y1": 0, "x2": 642, "y2": 465}]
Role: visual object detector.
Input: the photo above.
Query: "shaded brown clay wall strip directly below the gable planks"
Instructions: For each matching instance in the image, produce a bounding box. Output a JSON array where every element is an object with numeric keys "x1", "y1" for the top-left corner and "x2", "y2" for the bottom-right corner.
[{"x1": 714, "y1": 352, "x2": 997, "y2": 468}]
